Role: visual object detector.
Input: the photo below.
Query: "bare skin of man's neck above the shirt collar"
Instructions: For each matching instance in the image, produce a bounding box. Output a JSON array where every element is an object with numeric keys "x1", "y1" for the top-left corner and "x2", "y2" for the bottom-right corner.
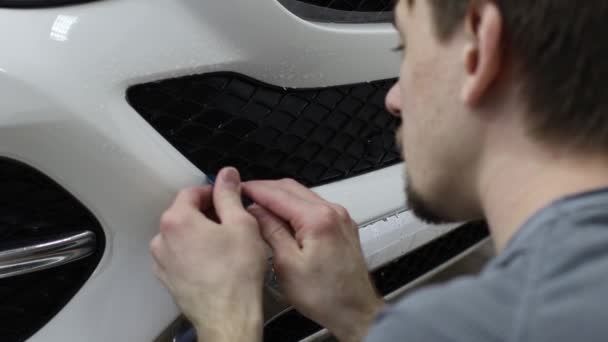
[{"x1": 480, "y1": 149, "x2": 608, "y2": 252}]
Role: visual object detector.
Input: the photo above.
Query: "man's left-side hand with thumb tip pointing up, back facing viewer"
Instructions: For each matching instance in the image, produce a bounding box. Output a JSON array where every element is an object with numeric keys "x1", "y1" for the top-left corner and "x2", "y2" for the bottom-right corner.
[{"x1": 150, "y1": 168, "x2": 267, "y2": 342}]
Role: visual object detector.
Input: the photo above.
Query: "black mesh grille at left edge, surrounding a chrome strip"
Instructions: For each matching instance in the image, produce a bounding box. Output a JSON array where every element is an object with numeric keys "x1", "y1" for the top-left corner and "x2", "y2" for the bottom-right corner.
[{"x1": 0, "y1": 158, "x2": 104, "y2": 342}]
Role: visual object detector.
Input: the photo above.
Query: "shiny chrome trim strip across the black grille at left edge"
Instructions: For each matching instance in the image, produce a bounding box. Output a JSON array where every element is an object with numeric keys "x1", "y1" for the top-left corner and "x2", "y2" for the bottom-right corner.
[{"x1": 0, "y1": 231, "x2": 96, "y2": 279}]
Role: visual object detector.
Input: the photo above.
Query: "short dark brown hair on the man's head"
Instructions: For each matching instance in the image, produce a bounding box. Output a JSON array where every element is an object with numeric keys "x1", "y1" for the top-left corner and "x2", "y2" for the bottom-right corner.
[{"x1": 428, "y1": 0, "x2": 608, "y2": 153}]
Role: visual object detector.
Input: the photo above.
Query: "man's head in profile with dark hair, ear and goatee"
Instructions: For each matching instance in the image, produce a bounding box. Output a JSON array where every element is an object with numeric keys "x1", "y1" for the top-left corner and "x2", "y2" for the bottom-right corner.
[{"x1": 387, "y1": 0, "x2": 608, "y2": 222}]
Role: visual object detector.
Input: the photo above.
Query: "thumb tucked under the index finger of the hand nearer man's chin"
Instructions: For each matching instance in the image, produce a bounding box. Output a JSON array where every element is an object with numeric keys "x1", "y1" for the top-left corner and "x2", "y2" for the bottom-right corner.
[{"x1": 247, "y1": 205, "x2": 300, "y2": 255}]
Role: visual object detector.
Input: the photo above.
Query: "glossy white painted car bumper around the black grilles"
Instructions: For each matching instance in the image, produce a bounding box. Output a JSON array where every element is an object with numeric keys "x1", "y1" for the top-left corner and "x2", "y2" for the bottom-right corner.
[{"x1": 0, "y1": 0, "x2": 452, "y2": 342}]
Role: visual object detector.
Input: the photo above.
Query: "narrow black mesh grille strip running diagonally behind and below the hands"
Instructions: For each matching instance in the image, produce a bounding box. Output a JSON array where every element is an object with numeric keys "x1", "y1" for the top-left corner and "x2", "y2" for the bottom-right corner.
[{"x1": 264, "y1": 223, "x2": 489, "y2": 342}]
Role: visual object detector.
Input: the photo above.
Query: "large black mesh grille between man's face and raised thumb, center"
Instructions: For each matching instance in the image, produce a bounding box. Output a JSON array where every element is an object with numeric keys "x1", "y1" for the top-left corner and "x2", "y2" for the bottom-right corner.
[{"x1": 127, "y1": 73, "x2": 400, "y2": 186}]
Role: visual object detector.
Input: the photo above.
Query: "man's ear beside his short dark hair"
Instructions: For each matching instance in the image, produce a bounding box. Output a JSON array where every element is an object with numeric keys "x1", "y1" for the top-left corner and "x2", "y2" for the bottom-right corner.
[{"x1": 460, "y1": 0, "x2": 503, "y2": 106}]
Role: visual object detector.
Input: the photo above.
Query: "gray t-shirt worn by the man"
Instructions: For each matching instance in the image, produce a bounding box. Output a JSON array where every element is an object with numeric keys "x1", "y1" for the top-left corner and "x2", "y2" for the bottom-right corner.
[{"x1": 366, "y1": 189, "x2": 608, "y2": 342}]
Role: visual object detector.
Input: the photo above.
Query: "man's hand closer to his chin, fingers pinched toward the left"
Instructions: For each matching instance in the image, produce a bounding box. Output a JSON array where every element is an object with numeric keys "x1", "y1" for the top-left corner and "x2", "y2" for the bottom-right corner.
[{"x1": 243, "y1": 179, "x2": 384, "y2": 341}]
